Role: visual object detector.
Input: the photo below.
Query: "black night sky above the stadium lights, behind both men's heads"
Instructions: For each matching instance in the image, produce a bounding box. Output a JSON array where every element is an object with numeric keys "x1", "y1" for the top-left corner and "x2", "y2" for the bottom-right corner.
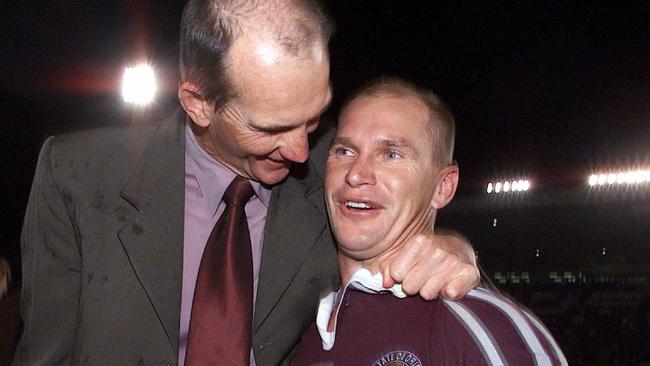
[{"x1": 0, "y1": 0, "x2": 650, "y2": 264}]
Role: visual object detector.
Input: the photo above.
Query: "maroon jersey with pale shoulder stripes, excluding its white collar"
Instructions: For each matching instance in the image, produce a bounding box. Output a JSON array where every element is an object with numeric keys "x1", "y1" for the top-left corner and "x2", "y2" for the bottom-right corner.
[{"x1": 292, "y1": 288, "x2": 567, "y2": 366}]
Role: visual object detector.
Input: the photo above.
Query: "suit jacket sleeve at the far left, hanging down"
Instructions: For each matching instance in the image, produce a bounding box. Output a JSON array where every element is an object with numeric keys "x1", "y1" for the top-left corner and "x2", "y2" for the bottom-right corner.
[{"x1": 13, "y1": 138, "x2": 81, "y2": 365}]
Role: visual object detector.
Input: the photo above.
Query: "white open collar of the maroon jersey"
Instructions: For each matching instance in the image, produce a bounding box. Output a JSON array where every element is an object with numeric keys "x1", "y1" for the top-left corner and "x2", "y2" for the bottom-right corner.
[{"x1": 316, "y1": 268, "x2": 406, "y2": 351}]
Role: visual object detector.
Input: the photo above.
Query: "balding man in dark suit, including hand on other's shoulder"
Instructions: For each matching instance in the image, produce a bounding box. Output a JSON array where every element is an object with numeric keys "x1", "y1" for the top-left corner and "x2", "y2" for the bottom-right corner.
[{"x1": 14, "y1": 0, "x2": 478, "y2": 365}]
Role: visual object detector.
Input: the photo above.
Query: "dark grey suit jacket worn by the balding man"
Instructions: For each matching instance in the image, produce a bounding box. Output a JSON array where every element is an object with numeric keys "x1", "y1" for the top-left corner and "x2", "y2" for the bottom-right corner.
[{"x1": 14, "y1": 114, "x2": 338, "y2": 366}]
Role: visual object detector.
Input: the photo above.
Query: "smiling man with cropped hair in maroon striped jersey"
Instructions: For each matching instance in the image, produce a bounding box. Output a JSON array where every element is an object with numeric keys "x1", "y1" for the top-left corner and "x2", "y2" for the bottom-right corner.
[{"x1": 293, "y1": 79, "x2": 566, "y2": 366}]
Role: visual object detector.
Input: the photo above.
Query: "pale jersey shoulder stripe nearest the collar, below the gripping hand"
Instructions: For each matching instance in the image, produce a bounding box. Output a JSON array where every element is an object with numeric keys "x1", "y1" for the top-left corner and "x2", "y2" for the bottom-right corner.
[{"x1": 444, "y1": 300, "x2": 505, "y2": 366}]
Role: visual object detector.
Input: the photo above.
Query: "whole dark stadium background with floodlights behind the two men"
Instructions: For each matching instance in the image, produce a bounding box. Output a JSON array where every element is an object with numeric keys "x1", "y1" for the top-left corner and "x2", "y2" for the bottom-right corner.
[{"x1": 0, "y1": 0, "x2": 650, "y2": 365}]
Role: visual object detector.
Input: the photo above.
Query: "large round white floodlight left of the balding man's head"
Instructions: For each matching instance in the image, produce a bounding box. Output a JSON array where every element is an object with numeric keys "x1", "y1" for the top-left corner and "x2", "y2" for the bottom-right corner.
[{"x1": 122, "y1": 64, "x2": 157, "y2": 106}]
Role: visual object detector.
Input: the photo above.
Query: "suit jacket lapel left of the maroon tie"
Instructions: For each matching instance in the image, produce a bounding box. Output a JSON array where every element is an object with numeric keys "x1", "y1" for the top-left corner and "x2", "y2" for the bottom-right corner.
[{"x1": 118, "y1": 117, "x2": 185, "y2": 351}]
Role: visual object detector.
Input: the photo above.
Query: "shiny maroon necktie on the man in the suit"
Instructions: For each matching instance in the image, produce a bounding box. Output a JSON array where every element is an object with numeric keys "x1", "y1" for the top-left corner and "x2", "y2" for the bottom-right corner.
[{"x1": 185, "y1": 176, "x2": 253, "y2": 366}]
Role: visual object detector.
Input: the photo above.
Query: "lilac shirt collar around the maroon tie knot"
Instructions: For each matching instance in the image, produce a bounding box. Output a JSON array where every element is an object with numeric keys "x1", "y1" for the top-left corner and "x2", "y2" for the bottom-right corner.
[{"x1": 185, "y1": 122, "x2": 271, "y2": 214}]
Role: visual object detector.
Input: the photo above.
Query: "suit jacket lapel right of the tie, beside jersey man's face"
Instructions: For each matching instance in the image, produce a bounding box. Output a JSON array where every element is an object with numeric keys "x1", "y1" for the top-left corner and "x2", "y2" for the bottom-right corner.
[{"x1": 253, "y1": 161, "x2": 327, "y2": 332}]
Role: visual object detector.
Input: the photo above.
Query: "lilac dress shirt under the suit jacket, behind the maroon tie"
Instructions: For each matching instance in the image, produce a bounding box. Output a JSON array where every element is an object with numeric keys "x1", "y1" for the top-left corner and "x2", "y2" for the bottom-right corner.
[{"x1": 178, "y1": 124, "x2": 271, "y2": 366}]
